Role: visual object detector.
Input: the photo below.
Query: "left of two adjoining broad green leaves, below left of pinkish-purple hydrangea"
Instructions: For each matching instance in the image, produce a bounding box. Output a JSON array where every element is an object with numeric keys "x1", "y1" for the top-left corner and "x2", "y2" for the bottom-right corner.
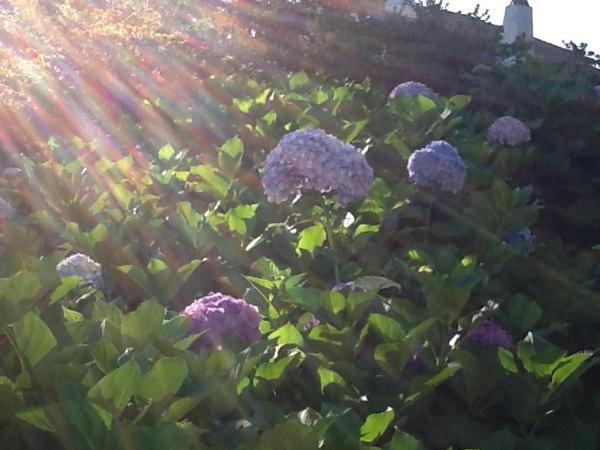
[{"x1": 88, "y1": 360, "x2": 142, "y2": 411}]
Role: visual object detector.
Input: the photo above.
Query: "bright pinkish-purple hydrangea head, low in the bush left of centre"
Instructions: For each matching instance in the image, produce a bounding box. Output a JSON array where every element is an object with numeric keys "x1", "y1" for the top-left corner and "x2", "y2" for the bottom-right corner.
[{"x1": 182, "y1": 292, "x2": 260, "y2": 349}]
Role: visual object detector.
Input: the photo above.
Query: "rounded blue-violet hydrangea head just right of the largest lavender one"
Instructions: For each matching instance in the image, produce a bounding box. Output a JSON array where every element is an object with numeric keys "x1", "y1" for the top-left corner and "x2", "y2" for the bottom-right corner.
[{"x1": 407, "y1": 141, "x2": 467, "y2": 194}]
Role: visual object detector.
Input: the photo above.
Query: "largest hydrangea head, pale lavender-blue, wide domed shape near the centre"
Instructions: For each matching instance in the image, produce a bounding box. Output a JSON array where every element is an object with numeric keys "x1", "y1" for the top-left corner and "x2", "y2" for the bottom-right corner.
[{"x1": 262, "y1": 129, "x2": 373, "y2": 206}]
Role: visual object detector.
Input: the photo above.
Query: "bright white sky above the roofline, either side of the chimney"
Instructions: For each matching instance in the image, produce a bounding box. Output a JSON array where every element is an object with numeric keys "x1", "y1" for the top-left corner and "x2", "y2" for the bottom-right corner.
[{"x1": 446, "y1": 0, "x2": 600, "y2": 53}]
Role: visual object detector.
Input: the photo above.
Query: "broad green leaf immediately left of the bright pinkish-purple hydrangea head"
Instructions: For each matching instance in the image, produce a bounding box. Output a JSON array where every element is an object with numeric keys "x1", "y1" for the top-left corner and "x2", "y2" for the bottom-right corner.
[{"x1": 121, "y1": 300, "x2": 165, "y2": 348}]
